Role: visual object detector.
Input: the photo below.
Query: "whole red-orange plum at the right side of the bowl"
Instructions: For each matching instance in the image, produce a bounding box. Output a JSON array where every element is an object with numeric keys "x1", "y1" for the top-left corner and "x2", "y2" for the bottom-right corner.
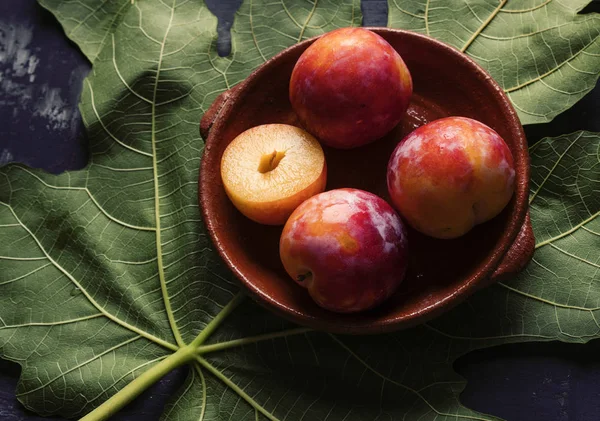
[{"x1": 387, "y1": 117, "x2": 515, "y2": 239}]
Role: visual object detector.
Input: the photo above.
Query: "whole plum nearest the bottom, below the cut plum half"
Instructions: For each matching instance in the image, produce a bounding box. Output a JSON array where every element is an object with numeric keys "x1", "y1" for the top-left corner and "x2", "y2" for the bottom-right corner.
[{"x1": 279, "y1": 188, "x2": 408, "y2": 313}]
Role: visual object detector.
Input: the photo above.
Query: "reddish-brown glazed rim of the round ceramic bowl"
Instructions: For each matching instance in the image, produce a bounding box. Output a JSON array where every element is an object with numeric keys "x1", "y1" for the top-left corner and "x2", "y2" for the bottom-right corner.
[{"x1": 198, "y1": 27, "x2": 530, "y2": 334}]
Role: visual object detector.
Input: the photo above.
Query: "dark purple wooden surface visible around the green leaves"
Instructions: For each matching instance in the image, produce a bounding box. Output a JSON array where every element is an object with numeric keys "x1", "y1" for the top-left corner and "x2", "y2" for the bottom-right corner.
[{"x1": 0, "y1": 0, "x2": 600, "y2": 421}]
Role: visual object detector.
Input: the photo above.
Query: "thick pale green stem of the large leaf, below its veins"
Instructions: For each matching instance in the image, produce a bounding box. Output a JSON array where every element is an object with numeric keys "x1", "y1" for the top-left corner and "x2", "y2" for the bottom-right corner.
[{"x1": 80, "y1": 346, "x2": 195, "y2": 421}]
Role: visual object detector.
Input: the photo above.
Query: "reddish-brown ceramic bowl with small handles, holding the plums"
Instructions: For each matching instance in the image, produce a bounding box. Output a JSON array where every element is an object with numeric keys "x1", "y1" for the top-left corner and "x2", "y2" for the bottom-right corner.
[{"x1": 199, "y1": 29, "x2": 534, "y2": 334}]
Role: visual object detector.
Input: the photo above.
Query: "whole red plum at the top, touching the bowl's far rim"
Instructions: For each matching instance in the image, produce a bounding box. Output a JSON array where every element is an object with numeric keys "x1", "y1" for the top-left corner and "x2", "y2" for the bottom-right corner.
[{"x1": 289, "y1": 28, "x2": 412, "y2": 149}]
